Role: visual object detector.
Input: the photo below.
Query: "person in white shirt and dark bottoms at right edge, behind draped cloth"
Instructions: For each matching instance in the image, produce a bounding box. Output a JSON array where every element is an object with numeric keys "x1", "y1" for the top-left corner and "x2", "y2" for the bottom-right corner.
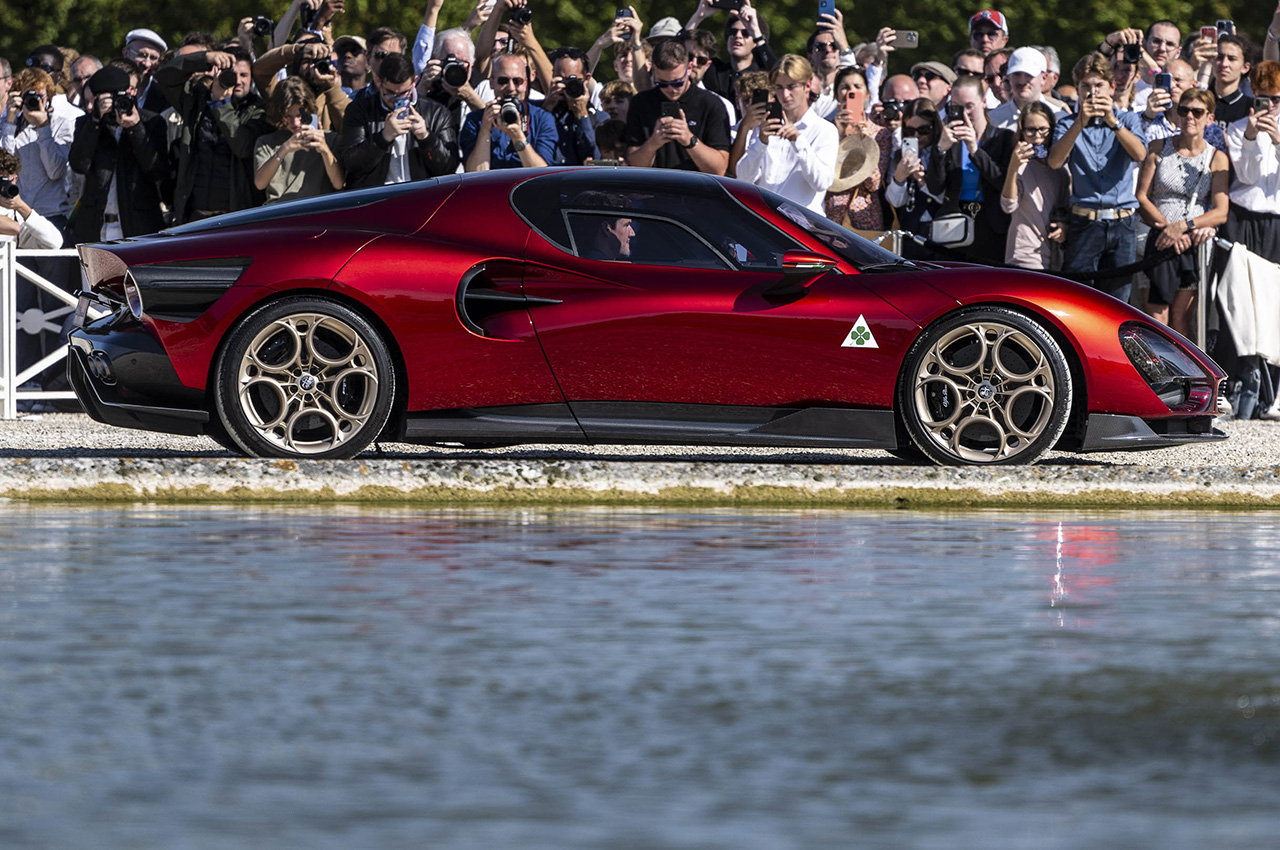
[{"x1": 1213, "y1": 61, "x2": 1280, "y2": 419}]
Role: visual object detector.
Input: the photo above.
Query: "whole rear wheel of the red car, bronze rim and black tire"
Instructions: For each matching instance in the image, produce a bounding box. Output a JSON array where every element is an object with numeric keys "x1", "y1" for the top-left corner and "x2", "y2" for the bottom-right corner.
[{"x1": 214, "y1": 296, "x2": 396, "y2": 460}]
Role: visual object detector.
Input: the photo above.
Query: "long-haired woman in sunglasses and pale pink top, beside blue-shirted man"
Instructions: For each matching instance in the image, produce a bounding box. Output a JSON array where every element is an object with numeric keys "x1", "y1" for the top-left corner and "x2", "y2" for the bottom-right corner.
[{"x1": 1000, "y1": 101, "x2": 1070, "y2": 269}]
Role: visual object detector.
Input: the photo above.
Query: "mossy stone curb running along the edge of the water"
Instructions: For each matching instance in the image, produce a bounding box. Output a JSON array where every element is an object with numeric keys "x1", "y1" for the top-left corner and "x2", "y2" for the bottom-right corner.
[{"x1": 0, "y1": 457, "x2": 1280, "y2": 508}]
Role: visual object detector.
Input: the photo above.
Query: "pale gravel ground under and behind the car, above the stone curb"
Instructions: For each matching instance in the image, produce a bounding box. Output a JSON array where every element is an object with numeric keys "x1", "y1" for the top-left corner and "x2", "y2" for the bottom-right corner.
[{"x1": 0, "y1": 413, "x2": 1280, "y2": 470}]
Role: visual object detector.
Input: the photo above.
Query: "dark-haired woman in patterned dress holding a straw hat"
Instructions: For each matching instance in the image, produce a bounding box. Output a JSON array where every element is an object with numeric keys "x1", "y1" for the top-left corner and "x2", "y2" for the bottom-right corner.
[{"x1": 822, "y1": 68, "x2": 893, "y2": 230}]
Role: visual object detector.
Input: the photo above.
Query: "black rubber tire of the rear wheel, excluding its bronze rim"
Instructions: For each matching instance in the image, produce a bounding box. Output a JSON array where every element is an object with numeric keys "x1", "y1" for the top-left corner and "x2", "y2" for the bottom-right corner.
[{"x1": 214, "y1": 296, "x2": 396, "y2": 461}]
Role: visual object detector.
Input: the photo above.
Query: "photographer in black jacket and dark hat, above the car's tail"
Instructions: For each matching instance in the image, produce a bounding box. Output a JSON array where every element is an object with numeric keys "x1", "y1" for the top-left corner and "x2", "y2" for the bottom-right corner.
[{"x1": 70, "y1": 60, "x2": 169, "y2": 243}]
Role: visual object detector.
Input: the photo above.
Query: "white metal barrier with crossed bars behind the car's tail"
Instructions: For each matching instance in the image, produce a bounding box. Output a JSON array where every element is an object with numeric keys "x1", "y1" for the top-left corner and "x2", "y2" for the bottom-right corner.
[{"x1": 0, "y1": 239, "x2": 78, "y2": 419}]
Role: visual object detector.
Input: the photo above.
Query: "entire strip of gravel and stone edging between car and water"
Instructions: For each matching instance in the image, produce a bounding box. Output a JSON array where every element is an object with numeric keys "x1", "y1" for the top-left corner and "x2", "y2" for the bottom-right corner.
[{"x1": 0, "y1": 413, "x2": 1280, "y2": 508}]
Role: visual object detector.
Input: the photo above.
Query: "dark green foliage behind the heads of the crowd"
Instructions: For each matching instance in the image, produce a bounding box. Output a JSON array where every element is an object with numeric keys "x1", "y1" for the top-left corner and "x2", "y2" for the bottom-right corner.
[{"x1": 0, "y1": 0, "x2": 1274, "y2": 76}]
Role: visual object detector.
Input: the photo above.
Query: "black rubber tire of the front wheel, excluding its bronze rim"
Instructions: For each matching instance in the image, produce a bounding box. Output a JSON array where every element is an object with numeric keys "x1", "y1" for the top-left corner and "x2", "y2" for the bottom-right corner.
[{"x1": 897, "y1": 306, "x2": 1074, "y2": 466}]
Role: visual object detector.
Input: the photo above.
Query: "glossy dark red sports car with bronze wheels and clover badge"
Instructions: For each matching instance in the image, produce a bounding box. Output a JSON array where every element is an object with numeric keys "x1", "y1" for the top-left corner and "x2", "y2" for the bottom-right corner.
[{"x1": 69, "y1": 168, "x2": 1224, "y2": 463}]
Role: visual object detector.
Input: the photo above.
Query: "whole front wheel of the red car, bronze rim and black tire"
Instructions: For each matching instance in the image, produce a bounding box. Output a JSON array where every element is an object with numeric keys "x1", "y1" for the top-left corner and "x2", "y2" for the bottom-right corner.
[{"x1": 897, "y1": 307, "x2": 1073, "y2": 466}]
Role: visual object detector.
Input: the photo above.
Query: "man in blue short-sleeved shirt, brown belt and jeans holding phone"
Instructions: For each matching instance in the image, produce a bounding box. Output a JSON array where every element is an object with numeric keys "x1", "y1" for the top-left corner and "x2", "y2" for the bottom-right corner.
[{"x1": 1047, "y1": 52, "x2": 1147, "y2": 301}]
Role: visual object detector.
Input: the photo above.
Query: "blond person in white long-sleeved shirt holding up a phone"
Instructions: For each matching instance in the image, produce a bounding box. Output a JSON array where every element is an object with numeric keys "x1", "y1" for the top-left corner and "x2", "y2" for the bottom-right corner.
[{"x1": 737, "y1": 54, "x2": 840, "y2": 214}]
